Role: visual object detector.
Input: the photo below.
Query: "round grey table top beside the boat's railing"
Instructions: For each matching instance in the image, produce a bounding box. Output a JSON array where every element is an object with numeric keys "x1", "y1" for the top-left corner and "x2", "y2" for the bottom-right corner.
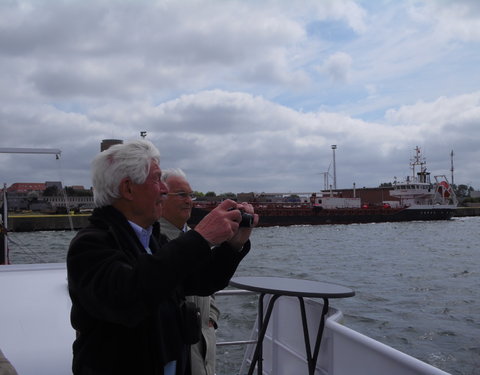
[{"x1": 230, "y1": 276, "x2": 355, "y2": 298}]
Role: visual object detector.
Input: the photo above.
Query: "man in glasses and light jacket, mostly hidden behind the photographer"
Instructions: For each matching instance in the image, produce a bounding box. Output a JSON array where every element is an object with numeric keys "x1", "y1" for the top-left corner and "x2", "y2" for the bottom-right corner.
[{"x1": 159, "y1": 169, "x2": 220, "y2": 375}]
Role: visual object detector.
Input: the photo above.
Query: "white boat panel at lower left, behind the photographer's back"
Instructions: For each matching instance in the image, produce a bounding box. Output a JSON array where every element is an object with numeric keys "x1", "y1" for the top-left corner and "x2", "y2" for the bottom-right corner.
[{"x1": 0, "y1": 264, "x2": 75, "y2": 375}]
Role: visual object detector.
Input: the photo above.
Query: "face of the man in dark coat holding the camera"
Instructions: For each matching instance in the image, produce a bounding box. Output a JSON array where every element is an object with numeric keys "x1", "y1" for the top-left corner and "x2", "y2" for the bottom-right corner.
[{"x1": 132, "y1": 162, "x2": 168, "y2": 228}]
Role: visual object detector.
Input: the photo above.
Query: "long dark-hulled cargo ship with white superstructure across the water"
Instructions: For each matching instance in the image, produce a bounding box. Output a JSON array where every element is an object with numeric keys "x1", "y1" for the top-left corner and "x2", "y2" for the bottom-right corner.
[{"x1": 189, "y1": 147, "x2": 458, "y2": 227}]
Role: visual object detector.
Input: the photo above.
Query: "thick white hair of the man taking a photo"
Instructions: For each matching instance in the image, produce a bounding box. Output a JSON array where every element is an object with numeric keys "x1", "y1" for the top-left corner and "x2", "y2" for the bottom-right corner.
[{"x1": 92, "y1": 140, "x2": 160, "y2": 207}]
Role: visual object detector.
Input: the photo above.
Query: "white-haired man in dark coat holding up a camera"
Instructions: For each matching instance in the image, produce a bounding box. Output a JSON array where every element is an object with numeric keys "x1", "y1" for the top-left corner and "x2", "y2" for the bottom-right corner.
[{"x1": 67, "y1": 140, "x2": 258, "y2": 375}]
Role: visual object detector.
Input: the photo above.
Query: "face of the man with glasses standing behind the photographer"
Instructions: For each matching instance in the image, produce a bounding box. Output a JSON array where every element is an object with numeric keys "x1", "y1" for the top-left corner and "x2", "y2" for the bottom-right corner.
[{"x1": 163, "y1": 176, "x2": 193, "y2": 229}]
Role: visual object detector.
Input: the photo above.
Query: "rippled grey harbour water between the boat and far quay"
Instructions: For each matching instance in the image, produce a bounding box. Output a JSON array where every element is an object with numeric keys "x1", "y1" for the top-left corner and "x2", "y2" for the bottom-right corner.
[{"x1": 4, "y1": 217, "x2": 480, "y2": 375}]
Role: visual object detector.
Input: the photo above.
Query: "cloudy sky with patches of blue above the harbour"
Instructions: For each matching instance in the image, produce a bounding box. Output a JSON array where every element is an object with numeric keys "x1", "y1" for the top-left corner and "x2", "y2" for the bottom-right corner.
[{"x1": 0, "y1": 0, "x2": 480, "y2": 193}]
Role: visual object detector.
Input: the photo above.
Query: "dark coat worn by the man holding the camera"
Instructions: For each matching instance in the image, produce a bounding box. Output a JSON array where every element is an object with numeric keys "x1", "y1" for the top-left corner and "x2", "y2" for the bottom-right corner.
[{"x1": 67, "y1": 206, "x2": 250, "y2": 375}]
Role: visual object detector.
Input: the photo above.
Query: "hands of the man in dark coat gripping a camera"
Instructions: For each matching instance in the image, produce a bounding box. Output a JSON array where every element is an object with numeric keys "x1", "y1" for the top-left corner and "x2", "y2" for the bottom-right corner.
[{"x1": 194, "y1": 199, "x2": 258, "y2": 250}]
